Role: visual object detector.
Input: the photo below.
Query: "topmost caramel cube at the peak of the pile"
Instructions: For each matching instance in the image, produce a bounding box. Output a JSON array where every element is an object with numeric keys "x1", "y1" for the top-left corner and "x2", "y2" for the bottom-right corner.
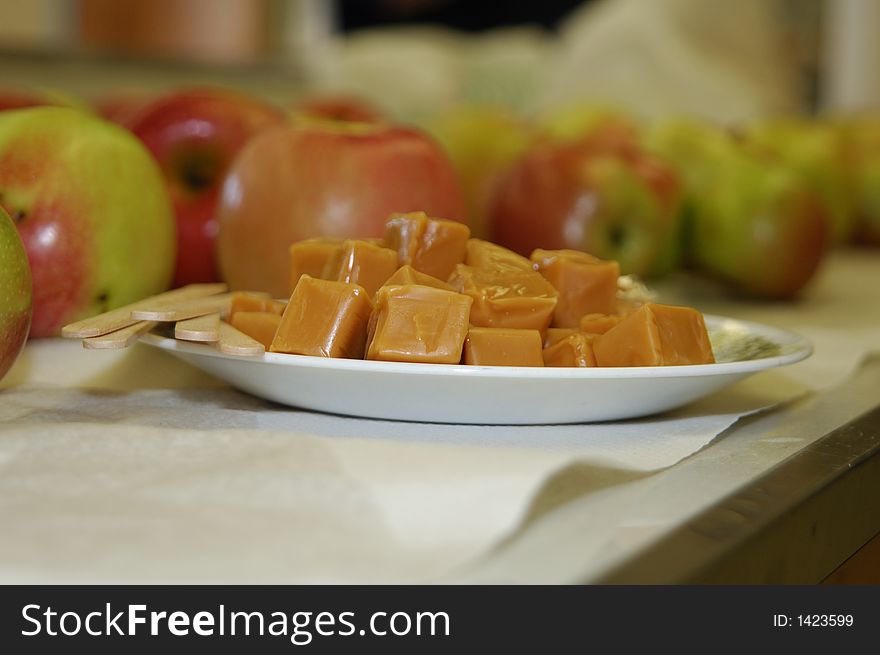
[{"x1": 385, "y1": 212, "x2": 471, "y2": 280}]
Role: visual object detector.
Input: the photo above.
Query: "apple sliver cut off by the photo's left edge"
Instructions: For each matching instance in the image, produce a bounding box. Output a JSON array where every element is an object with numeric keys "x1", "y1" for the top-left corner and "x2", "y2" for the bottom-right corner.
[{"x1": 0, "y1": 208, "x2": 32, "y2": 379}]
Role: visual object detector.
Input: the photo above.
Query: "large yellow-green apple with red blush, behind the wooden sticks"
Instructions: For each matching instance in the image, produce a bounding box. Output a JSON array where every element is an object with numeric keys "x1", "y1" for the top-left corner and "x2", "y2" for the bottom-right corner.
[{"x1": 0, "y1": 107, "x2": 175, "y2": 337}]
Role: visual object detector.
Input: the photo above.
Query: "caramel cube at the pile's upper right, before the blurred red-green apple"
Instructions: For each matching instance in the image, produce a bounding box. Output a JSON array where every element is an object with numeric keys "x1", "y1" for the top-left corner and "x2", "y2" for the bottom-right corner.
[{"x1": 531, "y1": 250, "x2": 620, "y2": 327}]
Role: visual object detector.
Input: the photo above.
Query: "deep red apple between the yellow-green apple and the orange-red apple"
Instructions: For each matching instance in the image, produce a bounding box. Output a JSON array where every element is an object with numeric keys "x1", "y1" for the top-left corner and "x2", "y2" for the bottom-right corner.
[{"x1": 123, "y1": 89, "x2": 285, "y2": 286}]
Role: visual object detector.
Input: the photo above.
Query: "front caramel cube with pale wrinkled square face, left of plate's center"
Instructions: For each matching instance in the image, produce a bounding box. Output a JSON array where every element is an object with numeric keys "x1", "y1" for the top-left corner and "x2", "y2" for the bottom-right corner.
[{"x1": 367, "y1": 284, "x2": 472, "y2": 364}]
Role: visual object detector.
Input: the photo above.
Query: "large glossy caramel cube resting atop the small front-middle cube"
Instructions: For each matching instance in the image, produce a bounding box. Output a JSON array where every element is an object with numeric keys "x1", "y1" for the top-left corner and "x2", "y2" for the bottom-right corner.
[{"x1": 449, "y1": 264, "x2": 556, "y2": 332}]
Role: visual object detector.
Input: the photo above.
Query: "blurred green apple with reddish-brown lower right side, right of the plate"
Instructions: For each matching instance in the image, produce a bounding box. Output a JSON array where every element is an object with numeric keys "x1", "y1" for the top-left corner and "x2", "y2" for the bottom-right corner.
[{"x1": 647, "y1": 120, "x2": 831, "y2": 299}]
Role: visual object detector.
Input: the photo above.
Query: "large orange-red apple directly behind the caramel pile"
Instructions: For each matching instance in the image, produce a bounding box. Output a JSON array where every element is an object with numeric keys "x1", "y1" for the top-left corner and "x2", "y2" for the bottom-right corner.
[{"x1": 217, "y1": 120, "x2": 464, "y2": 297}]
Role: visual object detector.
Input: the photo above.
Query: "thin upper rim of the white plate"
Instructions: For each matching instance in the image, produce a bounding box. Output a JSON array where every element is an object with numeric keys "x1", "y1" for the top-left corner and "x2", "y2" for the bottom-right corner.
[{"x1": 139, "y1": 314, "x2": 814, "y2": 380}]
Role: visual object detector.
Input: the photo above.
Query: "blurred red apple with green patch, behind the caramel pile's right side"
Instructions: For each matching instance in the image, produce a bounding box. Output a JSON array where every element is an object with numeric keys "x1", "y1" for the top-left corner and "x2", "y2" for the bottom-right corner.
[{"x1": 490, "y1": 138, "x2": 681, "y2": 277}]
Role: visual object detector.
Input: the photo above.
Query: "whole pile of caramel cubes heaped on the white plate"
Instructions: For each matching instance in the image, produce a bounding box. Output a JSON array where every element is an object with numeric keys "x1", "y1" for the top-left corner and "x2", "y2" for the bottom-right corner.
[{"x1": 230, "y1": 212, "x2": 715, "y2": 367}]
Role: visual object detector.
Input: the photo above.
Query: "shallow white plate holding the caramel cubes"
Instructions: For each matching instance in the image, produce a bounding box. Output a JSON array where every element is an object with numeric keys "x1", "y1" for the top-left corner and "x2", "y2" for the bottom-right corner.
[{"x1": 141, "y1": 315, "x2": 812, "y2": 425}]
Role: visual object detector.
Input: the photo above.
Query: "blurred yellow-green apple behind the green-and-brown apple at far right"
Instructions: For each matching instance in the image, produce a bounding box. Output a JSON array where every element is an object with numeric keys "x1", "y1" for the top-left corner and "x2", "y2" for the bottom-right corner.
[{"x1": 744, "y1": 118, "x2": 855, "y2": 243}]
